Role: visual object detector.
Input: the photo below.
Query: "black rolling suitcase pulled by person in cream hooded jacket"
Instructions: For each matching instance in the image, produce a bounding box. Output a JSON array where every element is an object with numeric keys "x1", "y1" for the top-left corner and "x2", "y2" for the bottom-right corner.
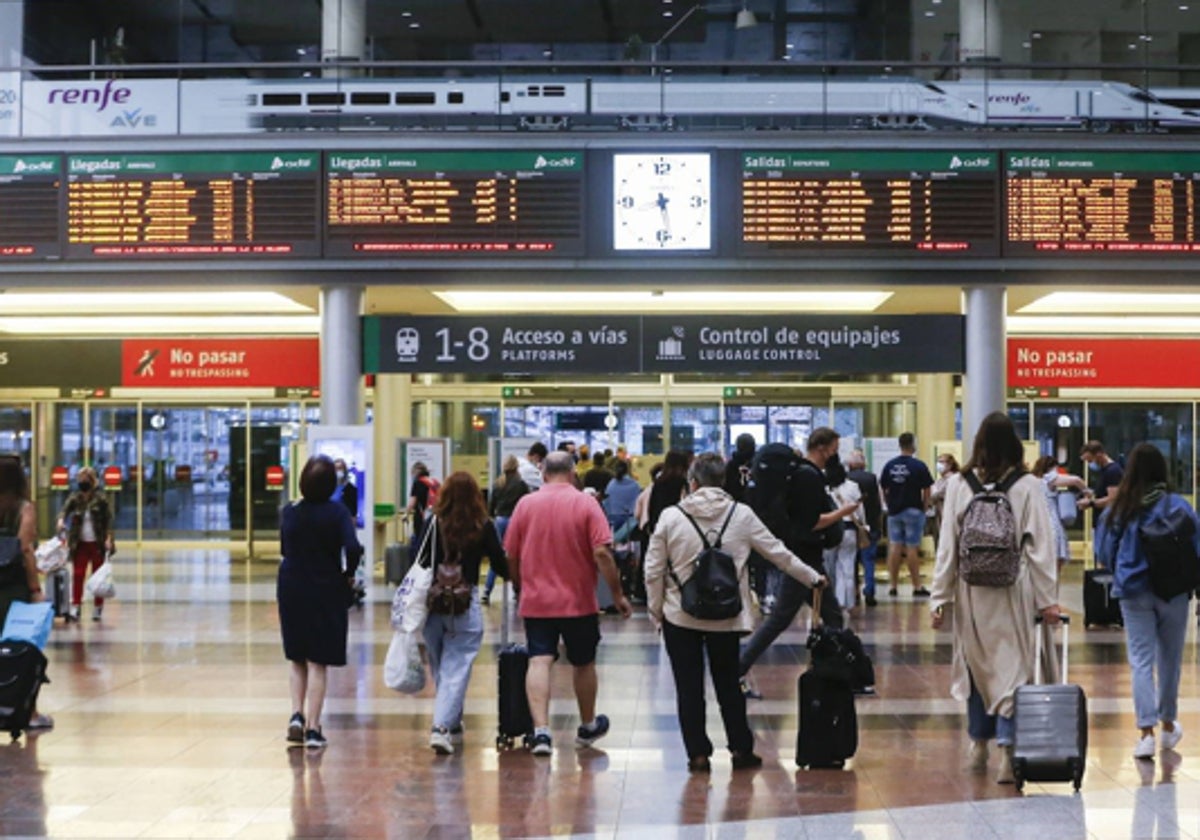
[{"x1": 796, "y1": 589, "x2": 858, "y2": 768}]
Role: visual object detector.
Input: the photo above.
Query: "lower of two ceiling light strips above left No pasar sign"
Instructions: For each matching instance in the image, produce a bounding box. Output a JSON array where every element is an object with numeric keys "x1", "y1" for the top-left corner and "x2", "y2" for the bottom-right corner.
[{"x1": 0, "y1": 314, "x2": 320, "y2": 336}]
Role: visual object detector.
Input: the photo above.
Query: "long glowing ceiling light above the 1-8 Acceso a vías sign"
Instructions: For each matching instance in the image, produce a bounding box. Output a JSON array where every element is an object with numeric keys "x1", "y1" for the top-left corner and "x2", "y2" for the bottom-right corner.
[{"x1": 433, "y1": 289, "x2": 893, "y2": 314}]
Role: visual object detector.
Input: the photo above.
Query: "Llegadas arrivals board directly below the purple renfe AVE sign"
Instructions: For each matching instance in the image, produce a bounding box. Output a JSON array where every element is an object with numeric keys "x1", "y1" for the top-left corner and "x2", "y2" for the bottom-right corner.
[{"x1": 66, "y1": 152, "x2": 320, "y2": 258}]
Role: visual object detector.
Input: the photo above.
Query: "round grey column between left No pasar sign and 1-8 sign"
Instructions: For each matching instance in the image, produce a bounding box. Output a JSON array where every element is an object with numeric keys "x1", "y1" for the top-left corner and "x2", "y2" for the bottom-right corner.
[{"x1": 320, "y1": 286, "x2": 364, "y2": 426}]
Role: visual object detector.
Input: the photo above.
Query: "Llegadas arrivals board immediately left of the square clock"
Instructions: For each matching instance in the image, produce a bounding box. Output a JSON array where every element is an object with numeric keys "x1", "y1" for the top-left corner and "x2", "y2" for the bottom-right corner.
[{"x1": 325, "y1": 151, "x2": 584, "y2": 257}]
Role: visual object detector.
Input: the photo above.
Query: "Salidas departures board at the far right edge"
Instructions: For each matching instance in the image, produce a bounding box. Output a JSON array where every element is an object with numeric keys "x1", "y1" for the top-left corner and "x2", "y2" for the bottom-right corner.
[{"x1": 1004, "y1": 152, "x2": 1200, "y2": 257}]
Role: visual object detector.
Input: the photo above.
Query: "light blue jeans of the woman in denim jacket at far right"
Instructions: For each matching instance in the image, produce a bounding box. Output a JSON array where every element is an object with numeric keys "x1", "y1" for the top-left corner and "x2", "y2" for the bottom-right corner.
[{"x1": 1121, "y1": 592, "x2": 1188, "y2": 728}]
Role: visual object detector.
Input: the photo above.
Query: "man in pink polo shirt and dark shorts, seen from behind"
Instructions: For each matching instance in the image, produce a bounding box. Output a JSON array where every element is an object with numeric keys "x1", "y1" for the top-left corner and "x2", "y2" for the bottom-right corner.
[{"x1": 504, "y1": 452, "x2": 632, "y2": 756}]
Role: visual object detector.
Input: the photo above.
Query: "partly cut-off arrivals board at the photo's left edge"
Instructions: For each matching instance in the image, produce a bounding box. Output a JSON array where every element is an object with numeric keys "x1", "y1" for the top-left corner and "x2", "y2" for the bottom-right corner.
[{"x1": 0, "y1": 155, "x2": 62, "y2": 260}]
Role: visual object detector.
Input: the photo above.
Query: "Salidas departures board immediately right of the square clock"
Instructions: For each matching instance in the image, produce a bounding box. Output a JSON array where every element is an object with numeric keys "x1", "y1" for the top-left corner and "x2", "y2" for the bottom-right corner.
[{"x1": 739, "y1": 150, "x2": 1000, "y2": 257}]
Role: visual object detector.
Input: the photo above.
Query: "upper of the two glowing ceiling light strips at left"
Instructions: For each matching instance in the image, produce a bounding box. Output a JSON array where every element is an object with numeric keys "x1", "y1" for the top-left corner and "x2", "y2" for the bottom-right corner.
[{"x1": 0, "y1": 290, "x2": 313, "y2": 316}]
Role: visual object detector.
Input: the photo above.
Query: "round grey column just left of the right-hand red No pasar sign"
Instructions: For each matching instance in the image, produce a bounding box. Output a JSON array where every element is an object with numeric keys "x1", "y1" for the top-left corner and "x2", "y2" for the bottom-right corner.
[{"x1": 962, "y1": 286, "x2": 1008, "y2": 454}]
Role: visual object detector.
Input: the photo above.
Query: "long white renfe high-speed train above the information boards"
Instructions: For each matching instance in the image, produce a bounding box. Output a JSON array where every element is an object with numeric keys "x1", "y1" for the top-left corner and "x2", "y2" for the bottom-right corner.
[{"x1": 171, "y1": 76, "x2": 1200, "y2": 134}]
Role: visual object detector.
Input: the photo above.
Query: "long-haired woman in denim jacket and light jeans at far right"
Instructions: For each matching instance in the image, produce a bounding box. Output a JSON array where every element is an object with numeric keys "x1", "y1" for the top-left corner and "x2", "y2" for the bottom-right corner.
[{"x1": 1096, "y1": 443, "x2": 1200, "y2": 758}]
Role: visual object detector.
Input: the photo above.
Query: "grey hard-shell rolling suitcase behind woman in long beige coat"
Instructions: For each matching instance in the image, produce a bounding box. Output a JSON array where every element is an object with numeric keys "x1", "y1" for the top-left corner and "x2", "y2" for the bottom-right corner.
[{"x1": 1013, "y1": 616, "x2": 1087, "y2": 791}]
